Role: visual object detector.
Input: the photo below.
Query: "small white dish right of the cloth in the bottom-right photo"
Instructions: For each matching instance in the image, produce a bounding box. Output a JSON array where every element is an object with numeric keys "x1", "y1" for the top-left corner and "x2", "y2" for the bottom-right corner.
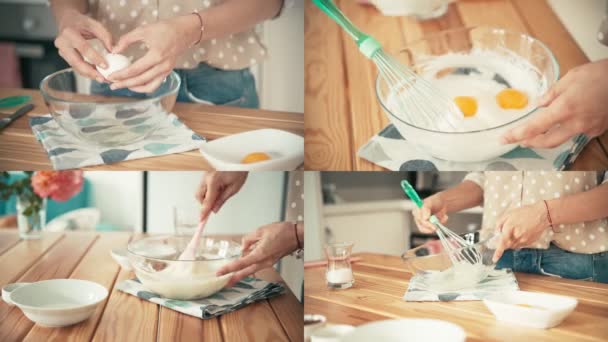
[{"x1": 483, "y1": 291, "x2": 578, "y2": 329}]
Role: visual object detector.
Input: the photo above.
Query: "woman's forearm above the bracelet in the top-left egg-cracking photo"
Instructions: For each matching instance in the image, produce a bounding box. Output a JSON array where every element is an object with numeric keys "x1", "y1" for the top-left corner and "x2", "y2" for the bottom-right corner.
[{"x1": 200, "y1": 0, "x2": 283, "y2": 40}]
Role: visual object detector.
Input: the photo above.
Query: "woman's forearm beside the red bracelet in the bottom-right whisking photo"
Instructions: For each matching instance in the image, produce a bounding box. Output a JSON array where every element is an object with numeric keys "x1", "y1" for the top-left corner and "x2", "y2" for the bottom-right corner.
[{"x1": 547, "y1": 183, "x2": 608, "y2": 225}]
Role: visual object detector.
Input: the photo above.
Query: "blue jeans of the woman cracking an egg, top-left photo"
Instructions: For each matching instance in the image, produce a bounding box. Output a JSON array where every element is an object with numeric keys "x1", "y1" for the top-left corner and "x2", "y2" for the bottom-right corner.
[{"x1": 91, "y1": 63, "x2": 260, "y2": 108}]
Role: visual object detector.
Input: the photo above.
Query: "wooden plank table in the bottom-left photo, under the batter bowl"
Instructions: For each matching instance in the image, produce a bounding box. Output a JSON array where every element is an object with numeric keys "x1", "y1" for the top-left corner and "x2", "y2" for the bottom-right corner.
[{"x1": 0, "y1": 231, "x2": 303, "y2": 341}]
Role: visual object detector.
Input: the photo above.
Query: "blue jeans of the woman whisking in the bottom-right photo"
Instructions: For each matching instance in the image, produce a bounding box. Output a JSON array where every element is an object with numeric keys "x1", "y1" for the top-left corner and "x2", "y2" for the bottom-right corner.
[{"x1": 496, "y1": 244, "x2": 608, "y2": 283}]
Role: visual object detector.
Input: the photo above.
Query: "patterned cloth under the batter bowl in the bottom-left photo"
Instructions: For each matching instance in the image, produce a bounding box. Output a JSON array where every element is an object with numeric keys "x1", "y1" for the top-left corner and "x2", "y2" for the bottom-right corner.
[{"x1": 116, "y1": 277, "x2": 285, "y2": 319}]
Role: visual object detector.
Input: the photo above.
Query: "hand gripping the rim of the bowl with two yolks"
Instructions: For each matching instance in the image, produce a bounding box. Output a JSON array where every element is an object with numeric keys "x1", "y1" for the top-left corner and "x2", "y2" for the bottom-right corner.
[{"x1": 502, "y1": 59, "x2": 608, "y2": 148}]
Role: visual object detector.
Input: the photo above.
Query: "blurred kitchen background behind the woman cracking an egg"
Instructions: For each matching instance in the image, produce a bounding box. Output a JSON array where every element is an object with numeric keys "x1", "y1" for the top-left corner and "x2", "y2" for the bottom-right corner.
[{"x1": 0, "y1": 0, "x2": 304, "y2": 113}]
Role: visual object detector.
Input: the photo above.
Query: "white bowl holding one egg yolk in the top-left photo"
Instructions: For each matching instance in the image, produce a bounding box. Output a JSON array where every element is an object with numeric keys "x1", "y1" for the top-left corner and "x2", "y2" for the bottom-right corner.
[{"x1": 200, "y1": 129, "x2": 304, "y2": 171}]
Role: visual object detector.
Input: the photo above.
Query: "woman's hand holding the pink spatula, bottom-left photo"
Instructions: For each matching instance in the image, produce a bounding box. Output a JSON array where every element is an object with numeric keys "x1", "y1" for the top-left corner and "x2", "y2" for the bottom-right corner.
[{"x1": 195, "y1": 171, "x2": 247, "y2": 220}]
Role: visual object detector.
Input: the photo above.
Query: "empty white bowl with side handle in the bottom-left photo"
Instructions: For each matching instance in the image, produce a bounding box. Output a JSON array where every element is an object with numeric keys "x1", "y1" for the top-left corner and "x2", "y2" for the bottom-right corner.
[{"x1": 2, "y1": 279, "x2": 108, "y2": 327}]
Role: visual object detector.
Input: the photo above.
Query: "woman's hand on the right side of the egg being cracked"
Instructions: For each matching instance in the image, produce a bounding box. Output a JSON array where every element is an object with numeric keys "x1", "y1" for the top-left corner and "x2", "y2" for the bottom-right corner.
[{"x1": 108, "y1": 14, "x2": 200, "y2": 93}]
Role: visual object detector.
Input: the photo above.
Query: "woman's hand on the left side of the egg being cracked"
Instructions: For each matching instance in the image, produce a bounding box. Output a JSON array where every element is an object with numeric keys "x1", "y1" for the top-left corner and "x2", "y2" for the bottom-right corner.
[{"x1": 55, "y1": 10, "x2": 112, "y2": 83}]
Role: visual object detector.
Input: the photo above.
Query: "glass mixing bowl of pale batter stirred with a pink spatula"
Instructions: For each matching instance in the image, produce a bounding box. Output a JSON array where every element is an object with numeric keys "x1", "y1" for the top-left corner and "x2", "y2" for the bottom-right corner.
[{"x1": 127, "y1": 235, "x2": 241, "y2": 300}]
